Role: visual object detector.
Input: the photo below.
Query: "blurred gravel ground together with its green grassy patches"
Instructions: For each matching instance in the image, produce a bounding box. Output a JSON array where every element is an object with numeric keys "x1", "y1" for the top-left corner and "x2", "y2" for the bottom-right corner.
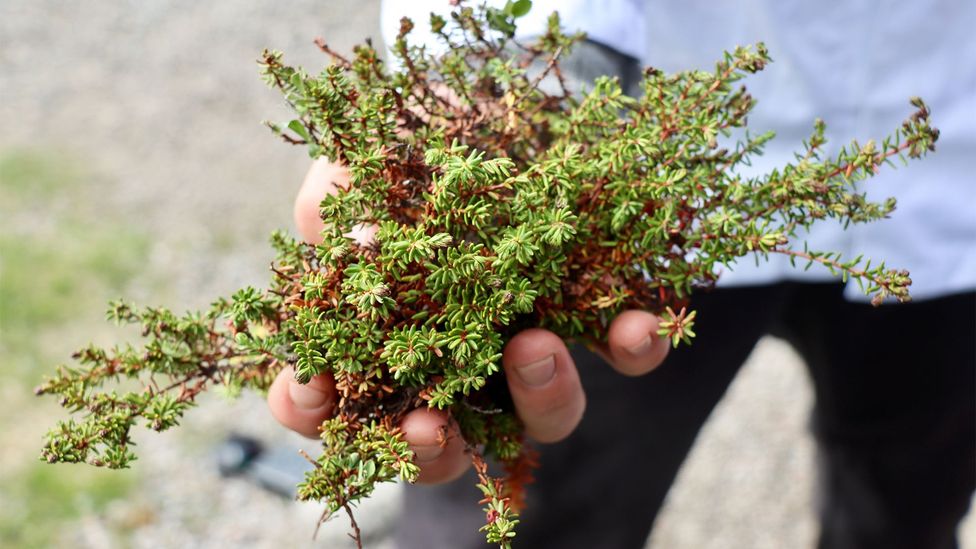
[{"x1": 0, "y1": 0, "x2": 976, "y2": 548}]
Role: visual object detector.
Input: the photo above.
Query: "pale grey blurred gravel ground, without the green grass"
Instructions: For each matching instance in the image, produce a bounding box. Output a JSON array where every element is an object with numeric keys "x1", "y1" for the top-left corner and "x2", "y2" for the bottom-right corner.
[{"x1": 0, "y1": 0, "x2": 976, "y2": 548}]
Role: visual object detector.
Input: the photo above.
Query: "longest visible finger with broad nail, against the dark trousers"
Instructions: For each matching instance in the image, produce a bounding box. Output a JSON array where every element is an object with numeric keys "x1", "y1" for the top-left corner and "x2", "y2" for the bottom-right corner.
[{"x1": 502, "y1": 328, "x2": 586, "y2": 442}]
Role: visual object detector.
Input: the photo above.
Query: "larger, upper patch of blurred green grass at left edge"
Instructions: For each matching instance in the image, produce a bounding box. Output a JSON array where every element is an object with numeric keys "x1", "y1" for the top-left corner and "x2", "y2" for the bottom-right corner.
[{"x1": 0, "y1": 151, "x2": 149, "y2": 382}]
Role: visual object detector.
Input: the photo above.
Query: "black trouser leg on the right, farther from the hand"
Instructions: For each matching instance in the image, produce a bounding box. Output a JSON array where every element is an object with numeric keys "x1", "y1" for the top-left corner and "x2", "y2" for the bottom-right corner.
[{"x1": 782, "y1": 285, "x2": 976, "y2": 549}]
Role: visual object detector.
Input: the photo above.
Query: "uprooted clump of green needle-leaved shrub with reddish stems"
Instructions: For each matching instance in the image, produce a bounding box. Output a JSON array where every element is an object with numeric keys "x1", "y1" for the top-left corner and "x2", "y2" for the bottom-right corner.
[{"x1": 39, "y1": 0, "x2": 938, "y2": 546}]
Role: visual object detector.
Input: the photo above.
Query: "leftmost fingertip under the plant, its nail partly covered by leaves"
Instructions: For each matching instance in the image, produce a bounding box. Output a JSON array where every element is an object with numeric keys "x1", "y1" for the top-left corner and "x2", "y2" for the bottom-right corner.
[{"x1": 268, "y1": 366, "x2": 337, "y2": 438}]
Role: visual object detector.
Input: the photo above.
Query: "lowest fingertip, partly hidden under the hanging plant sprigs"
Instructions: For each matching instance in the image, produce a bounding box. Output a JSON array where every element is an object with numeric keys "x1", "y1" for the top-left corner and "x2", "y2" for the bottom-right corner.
[{"x1": 400, "y1": 408, "x2": 471, "y2": 484}]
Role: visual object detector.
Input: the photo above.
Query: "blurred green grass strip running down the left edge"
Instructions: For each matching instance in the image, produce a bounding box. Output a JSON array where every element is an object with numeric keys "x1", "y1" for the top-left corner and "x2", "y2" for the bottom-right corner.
[{"x1": 0, "y1": 149, "x2": 150, "y2": 548}]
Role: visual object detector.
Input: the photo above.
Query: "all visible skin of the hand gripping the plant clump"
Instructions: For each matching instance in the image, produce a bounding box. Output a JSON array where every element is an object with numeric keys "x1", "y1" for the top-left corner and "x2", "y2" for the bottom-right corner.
[{"x1": 268, "y1": 160, "x2": 669, "y2": 483}]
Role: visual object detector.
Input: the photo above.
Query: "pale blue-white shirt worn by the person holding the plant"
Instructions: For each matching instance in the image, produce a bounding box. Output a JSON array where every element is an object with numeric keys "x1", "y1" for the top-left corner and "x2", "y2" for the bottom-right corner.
[{"x1": 381, "y1": 0, "x2": 976, "y2": 299}]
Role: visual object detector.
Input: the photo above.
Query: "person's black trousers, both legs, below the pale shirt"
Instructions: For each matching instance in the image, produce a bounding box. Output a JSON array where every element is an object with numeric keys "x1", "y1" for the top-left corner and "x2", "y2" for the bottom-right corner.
[{"x1": 397, "y1": 283, "x2": 976, "y2": 549}]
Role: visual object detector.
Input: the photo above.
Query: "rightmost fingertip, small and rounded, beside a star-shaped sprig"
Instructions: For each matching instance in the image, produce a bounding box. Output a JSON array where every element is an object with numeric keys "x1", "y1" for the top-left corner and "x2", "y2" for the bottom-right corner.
[{"x1": 604, "y1": 311, "x2": 670, "y2": 376}]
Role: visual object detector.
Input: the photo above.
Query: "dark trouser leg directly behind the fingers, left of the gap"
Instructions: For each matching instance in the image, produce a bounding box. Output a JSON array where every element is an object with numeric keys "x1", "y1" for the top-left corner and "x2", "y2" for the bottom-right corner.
[{"x1": 397, "y1": 287, "x2": 784, "y2": 549}]
